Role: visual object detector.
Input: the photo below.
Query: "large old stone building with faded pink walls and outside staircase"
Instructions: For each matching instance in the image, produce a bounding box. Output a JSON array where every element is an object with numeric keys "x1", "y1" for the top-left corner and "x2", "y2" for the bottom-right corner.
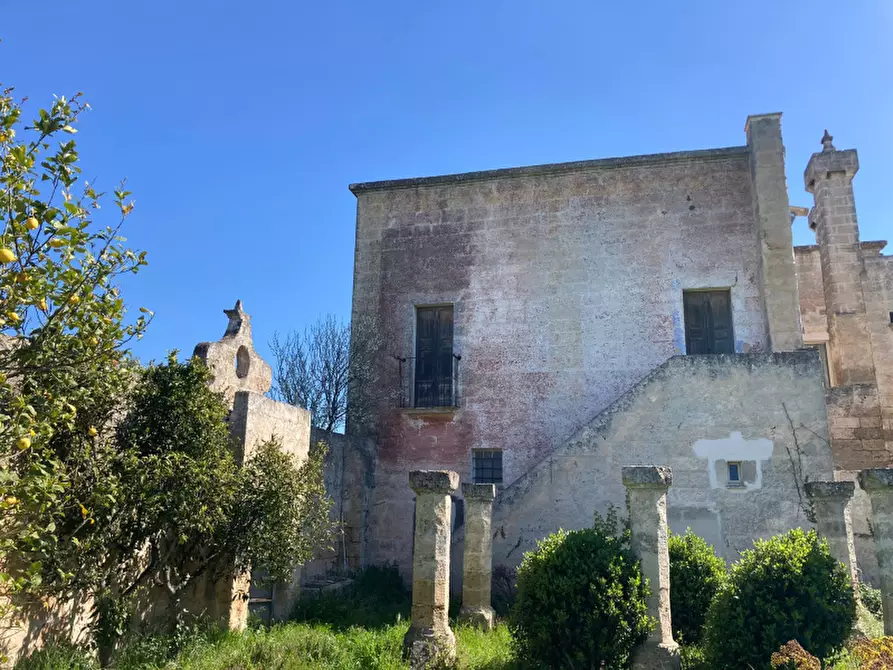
[{"x1": 345, "y1": 114, "x2": 893, "y2": 584}]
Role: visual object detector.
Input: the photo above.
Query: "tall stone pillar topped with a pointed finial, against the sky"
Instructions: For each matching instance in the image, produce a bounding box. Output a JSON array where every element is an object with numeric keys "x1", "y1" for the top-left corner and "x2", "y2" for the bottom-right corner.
[{"x1": 803, "y1": 130, "x2": 875, "y2": 386}]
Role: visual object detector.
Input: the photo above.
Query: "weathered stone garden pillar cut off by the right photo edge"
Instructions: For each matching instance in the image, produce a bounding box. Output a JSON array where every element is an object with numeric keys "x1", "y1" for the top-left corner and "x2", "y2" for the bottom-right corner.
[{"x1": 859, "y1": 468, "x2": 893, "y2": 635}]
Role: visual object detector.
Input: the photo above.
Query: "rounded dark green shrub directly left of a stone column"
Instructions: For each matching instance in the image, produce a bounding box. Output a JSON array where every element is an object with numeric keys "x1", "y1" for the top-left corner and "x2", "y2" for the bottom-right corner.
[{"x1": 509, "y1": 512, "x2": 653, "y2": 668}]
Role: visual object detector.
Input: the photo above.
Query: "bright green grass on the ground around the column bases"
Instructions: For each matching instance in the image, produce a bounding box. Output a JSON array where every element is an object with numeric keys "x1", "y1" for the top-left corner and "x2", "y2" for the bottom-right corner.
[{"x1": 16, "y1": 567, "x2": 883, "y2": 670}]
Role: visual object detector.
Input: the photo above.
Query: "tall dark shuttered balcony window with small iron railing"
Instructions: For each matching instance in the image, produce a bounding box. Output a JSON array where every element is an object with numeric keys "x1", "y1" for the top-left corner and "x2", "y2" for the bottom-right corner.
[{"x1": 414, "y1": 305, "x2": 455, "y2": 407}]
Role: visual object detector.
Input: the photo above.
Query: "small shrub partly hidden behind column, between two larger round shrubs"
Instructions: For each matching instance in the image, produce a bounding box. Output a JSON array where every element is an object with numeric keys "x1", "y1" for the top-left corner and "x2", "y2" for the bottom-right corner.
[{"x1": 669, "y1": 529, "x2": 726, "y2": 644}]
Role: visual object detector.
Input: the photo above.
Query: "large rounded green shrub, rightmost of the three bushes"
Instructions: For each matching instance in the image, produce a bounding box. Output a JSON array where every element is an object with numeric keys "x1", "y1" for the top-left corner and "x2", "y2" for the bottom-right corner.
[{"x1": 704, "y1": 528, "x2": 856, "y2": 669}]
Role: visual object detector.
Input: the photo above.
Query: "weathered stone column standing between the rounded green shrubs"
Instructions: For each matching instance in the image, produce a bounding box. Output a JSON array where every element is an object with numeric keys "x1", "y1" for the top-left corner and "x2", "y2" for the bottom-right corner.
[{"x1": 622, "y1": 465, "x2": 680, "y2": 670}]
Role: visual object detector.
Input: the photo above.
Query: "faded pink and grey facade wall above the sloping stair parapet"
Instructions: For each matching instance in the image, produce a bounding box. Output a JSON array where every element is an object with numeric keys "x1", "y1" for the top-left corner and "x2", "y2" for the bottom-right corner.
[{"x1": 354, "y1": 148, "x2": 767, "y2": 566}]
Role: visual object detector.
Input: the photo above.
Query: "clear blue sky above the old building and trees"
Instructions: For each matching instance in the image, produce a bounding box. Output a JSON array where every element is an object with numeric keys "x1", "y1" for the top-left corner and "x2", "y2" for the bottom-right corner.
[{"x1": 0, "y1": 0, "x2": 893, "y2": 368}]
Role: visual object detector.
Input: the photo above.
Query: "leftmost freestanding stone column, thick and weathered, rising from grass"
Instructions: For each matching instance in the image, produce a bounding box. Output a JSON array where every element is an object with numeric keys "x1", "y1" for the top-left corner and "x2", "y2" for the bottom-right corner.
[{"x1": 403, "y1": 470, "x2": 459, "y2": 668}]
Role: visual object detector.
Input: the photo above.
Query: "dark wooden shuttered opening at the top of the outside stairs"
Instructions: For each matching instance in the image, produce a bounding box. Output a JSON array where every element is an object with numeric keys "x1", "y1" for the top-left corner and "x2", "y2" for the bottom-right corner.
[{"x1": 682, "y1": 290, "x2": 735, "y2": 355}]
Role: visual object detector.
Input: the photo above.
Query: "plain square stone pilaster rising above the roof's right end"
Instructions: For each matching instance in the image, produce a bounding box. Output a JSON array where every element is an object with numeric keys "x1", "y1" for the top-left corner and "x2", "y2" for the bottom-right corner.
[{"x1": 744, "y1": 113, "x2": 803, "y2": 351}]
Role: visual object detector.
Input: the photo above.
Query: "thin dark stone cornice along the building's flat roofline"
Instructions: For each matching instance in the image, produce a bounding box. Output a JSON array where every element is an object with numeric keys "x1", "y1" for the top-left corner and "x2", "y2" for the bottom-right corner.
[{"x1": 348, "y1": 146, "x2": 747, "y2": 195}]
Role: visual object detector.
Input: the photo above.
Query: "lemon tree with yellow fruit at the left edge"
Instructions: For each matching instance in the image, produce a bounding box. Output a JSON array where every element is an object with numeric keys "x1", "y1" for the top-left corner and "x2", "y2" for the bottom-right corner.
[{"x1": 0, "y1": 88, "x2": 151, "y2": 614}]
